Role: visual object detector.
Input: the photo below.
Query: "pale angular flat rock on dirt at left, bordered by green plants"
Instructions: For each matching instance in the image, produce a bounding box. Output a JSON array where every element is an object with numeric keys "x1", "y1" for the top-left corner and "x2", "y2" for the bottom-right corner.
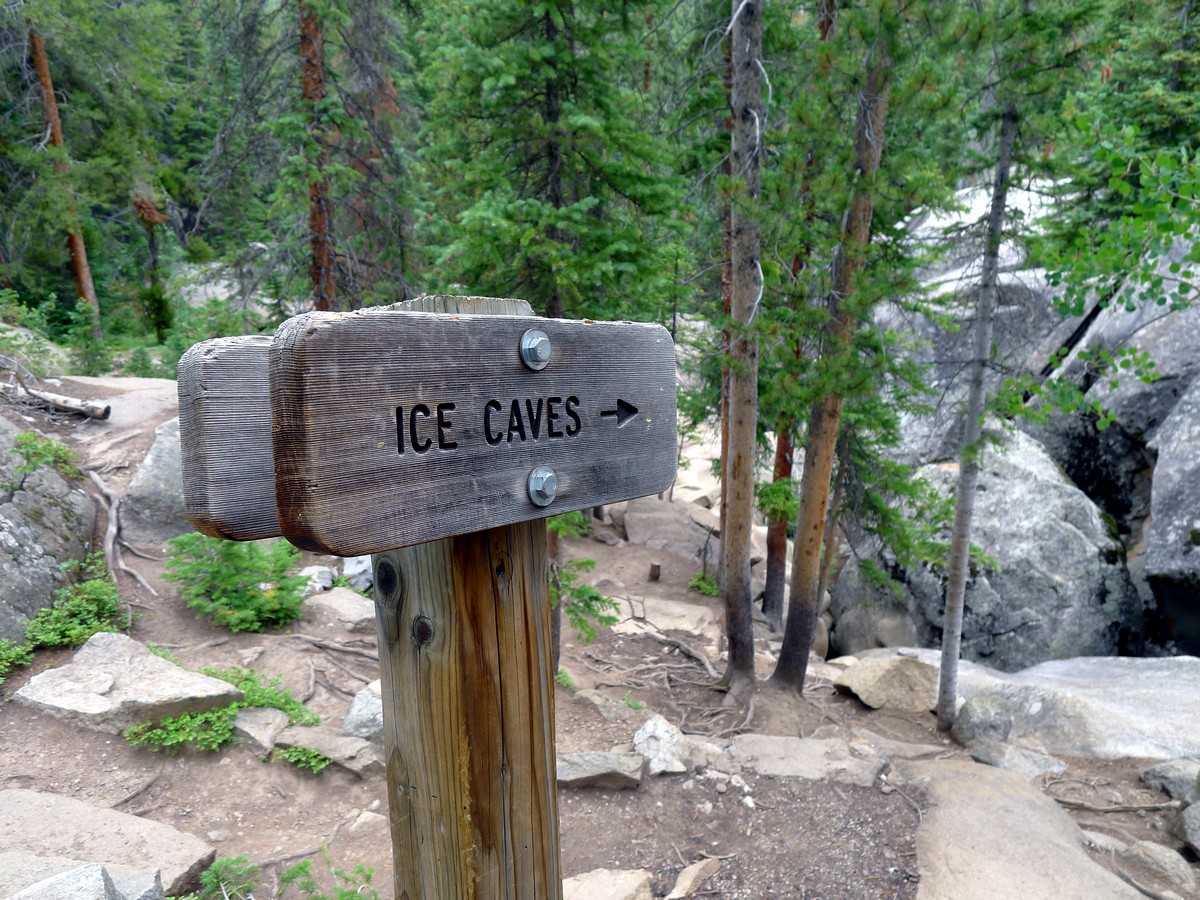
[{"x1": 13, "y1": 634, "x2": 242, "y2": 734}]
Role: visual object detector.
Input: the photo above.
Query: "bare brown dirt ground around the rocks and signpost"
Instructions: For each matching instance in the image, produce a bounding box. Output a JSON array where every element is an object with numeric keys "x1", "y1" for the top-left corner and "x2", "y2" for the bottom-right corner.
[{"x1": 0, "y1": 376, "x2": 1185, "y2": 900}]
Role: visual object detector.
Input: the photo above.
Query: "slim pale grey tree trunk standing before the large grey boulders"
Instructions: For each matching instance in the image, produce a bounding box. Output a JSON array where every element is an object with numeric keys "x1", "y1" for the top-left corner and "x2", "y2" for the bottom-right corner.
[{"x1": 937, "y1": 103, "x2": 1019, "y2": 731}]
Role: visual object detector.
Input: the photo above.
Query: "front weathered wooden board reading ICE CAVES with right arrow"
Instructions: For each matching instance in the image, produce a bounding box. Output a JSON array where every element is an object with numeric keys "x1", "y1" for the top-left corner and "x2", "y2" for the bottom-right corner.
[{"x1": 270, "y1": 310, "x2": 677, "y2": 556}]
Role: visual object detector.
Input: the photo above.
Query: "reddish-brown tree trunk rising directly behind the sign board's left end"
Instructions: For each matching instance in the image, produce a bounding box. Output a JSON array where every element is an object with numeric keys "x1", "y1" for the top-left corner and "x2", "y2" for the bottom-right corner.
[{"x1": 299, "y1": 0, "x2": 337, "y2": 310}]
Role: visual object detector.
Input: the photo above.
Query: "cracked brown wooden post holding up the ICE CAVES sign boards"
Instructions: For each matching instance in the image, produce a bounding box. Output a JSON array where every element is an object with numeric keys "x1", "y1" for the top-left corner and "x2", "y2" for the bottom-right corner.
[{"x1": 372, "y1": 300, "x2": 562, "y2": 900}]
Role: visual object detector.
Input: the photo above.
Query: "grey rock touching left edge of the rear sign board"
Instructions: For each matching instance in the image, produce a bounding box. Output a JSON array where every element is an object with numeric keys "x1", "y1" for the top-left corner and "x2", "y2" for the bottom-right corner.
[{"x1": 121, "y1": 418, "x2": 192, "y2": 547}]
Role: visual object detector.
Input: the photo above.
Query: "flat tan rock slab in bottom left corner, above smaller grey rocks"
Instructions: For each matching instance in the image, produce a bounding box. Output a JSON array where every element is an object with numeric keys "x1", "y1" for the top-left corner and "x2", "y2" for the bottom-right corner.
[{"x1": 0, "y1": 788, "x2": 216, "y2": 894}]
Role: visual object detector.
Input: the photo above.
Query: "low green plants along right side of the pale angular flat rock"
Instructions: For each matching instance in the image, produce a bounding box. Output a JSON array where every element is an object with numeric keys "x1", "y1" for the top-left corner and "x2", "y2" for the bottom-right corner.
[{"x1": 125, "y1": 668, "x2": 320, "y2": 752}]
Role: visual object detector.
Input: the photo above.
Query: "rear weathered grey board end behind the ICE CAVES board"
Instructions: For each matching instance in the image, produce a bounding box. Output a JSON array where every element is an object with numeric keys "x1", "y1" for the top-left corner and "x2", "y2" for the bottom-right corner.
[{"x1": 179, "y1": 335, "x2": 281, "y2": 541}]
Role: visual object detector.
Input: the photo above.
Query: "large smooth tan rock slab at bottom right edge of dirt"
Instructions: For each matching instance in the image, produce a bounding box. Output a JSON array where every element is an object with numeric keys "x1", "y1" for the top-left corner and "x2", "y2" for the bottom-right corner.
[{"x1": 899, "y1": 760, "x2": 1142, "y2": 900}]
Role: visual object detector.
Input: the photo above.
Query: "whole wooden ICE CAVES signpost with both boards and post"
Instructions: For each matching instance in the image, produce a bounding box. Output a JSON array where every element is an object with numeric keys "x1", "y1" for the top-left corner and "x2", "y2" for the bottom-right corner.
[{"x1": 180, "y1": 298, "x2": 676, "y2": 900}]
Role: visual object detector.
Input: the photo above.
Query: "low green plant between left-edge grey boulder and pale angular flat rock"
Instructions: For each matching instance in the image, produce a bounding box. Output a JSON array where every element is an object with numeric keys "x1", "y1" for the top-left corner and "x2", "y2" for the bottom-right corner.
[{"x1": 25, "y1": 553, "x2": 121, "y2": 650}]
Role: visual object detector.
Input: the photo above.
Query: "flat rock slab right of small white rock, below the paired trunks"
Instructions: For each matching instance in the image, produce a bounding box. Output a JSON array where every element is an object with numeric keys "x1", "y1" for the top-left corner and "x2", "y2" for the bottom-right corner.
[{"x1": 730, "y1": 734, "x2": 887, "y2": 787}]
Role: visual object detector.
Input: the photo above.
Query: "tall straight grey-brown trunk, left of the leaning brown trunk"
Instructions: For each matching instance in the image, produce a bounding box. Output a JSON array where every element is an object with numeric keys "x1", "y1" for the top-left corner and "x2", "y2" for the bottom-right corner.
[{"x1": 721, "y1": 0, "x2": 762, "y2": 694}]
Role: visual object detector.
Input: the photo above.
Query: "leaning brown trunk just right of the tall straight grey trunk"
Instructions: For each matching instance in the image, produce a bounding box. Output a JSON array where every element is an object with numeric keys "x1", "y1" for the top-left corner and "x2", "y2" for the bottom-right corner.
[{"x1": 770, "y1": 43, "x2": 892, "y2": 692}]
